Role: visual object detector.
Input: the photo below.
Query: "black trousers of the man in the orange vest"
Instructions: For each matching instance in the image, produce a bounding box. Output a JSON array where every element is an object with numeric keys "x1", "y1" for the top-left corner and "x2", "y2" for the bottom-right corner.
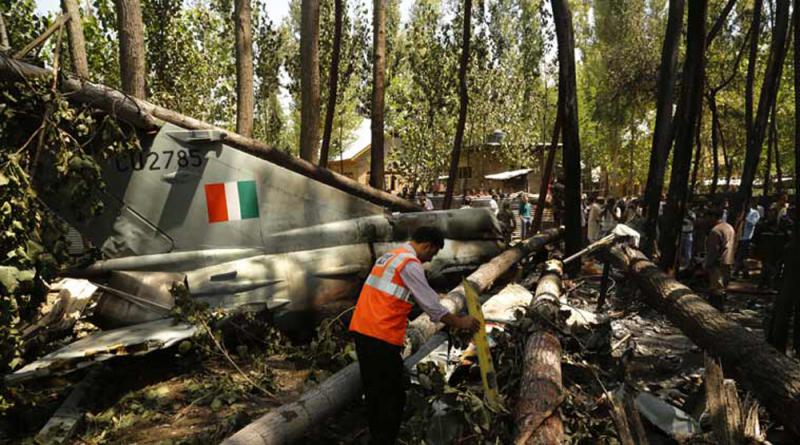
[{"x1": 353, "y1": 332, "x2": 406, "y2": 445}]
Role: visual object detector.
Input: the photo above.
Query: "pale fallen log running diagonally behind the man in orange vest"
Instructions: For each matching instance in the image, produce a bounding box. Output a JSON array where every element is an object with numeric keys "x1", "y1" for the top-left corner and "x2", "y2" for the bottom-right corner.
[{"x1": 223, "y1": 229, "x2": 562, "y2": 445}]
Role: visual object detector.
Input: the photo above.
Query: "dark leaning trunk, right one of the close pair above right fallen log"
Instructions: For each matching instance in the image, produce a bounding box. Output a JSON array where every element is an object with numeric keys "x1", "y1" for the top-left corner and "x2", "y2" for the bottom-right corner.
[{"x1": 659, "y1": 0, "x2": 708, "y2": 270}]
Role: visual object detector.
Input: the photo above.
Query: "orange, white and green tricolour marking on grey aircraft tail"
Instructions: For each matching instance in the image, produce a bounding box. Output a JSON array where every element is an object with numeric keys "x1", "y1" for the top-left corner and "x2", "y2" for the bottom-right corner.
[{"x1": 205, "y1": 181, "x2": 258, "y2": 223}]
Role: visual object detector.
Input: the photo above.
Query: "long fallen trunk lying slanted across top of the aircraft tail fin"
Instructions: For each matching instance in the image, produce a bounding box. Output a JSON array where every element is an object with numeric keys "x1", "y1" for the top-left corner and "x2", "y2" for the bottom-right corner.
[{"x1": 0, "y1": 54, "x2": 422, "y2": 212}]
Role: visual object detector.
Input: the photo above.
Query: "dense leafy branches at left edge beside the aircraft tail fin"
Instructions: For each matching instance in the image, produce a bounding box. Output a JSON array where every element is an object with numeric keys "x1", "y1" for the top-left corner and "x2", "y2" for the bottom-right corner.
[{"x1": 0, "y1": 72, "x2": 138, "y2": 408}]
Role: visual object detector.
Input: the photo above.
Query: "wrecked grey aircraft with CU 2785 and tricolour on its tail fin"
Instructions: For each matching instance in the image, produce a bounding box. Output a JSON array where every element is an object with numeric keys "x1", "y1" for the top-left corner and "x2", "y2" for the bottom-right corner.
[{"x1": 0, "y1": 54, "x2": 502, "y2": 383}]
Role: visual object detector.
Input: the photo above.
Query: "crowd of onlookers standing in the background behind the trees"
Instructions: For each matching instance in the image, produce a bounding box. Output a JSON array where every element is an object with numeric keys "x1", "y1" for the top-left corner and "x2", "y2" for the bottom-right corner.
[{"x1": 401, "y1": 185, "x2": 795, "y2": 306}]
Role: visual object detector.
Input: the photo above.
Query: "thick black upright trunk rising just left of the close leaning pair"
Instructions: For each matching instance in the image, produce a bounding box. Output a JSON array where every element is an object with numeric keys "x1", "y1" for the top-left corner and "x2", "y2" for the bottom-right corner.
[{"x1": 551, "y1": 0, "x2": 583, "y2": 270}]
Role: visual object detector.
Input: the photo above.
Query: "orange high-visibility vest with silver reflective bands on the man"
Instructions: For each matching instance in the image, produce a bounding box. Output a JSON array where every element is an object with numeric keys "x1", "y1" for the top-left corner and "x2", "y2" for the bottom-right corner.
[{"x1": 350, "y1": 248, "x2": 419, "y2": 346}]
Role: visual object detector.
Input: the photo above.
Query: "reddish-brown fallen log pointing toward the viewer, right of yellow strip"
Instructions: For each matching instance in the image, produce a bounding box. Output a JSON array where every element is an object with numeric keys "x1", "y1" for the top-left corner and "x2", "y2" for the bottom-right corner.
[{"x1": 514, "y1": 260, "x2": 564, "y2": 445}]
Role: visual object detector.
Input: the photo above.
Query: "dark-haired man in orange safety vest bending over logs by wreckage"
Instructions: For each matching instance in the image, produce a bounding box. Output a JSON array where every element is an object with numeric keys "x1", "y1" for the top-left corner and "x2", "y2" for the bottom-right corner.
[{"x1": 350, "y1": 227, "x2": 480, "y2": 445}]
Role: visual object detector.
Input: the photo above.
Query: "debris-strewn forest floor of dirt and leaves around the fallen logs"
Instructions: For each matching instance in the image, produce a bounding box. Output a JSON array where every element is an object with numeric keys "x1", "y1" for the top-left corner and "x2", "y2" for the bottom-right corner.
[{"x1": 0, "y1": 258, "x2": 797, "y2": 445}]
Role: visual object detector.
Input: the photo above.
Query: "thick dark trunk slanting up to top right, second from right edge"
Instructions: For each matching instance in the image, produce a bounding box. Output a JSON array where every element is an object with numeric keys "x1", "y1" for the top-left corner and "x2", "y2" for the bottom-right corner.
[{"x1": 730, "y1": 0, "x2": 789, "y2": 222}]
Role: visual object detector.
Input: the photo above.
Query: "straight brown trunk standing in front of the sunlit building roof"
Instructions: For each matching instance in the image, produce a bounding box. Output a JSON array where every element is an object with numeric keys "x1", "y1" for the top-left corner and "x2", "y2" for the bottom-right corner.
[{"x1": 369, "y1": 0, "x2": 390, "y2": 189}]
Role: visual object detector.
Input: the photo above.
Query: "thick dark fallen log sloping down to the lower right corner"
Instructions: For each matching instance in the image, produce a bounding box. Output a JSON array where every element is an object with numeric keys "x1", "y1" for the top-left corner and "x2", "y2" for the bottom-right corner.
[{"x1": 608, "y1": 247, "x2": 800, "y2": 434}]
